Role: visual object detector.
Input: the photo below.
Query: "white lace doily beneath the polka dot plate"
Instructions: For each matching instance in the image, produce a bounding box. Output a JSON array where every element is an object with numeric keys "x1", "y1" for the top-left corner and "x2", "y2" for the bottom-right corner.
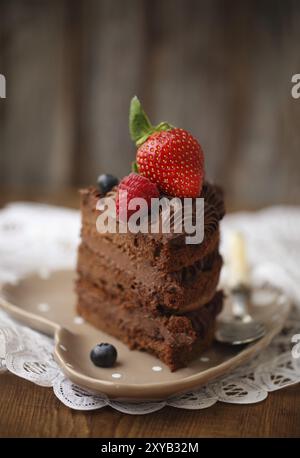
[{"x1": 0, "y1": 203, "x2": 300, "y2": 414}]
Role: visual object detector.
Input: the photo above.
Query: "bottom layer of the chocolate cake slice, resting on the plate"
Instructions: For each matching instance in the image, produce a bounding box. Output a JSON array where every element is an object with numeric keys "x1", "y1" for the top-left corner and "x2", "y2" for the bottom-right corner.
[{"x1": 77, "y1": 279, "x2": 222, "y2": 371}]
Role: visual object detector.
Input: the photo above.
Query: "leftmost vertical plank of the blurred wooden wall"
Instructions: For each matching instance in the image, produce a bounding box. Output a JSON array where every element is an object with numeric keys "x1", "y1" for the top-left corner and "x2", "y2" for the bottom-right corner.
[{"x1": 0, "y1": 0, "x2": 72, "y2": 189}]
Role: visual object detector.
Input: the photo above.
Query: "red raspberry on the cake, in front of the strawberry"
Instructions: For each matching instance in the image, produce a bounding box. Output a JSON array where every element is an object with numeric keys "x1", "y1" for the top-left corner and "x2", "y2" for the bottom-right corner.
[{"x1": 116, "y1": 173, "x2": 159, "y2": 221}]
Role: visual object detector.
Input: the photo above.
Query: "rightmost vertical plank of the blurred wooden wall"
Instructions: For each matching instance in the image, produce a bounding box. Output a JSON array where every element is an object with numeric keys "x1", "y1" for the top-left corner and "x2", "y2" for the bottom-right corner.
[{"x1": 225, "y1": 0, "x2": 300, "y2": 205}]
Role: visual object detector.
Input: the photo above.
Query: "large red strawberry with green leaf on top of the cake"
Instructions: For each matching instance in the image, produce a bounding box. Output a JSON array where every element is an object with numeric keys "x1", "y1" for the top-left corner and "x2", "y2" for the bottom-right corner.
[{"x1": 129, "y1": 97, "x2": 204, "y2": 197}]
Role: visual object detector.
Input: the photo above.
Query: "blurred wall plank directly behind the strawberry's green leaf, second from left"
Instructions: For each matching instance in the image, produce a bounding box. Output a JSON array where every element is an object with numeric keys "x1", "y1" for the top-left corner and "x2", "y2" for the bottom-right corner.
[{"x1": 80, "y1": 0, "x2": 143, "y2": 183}]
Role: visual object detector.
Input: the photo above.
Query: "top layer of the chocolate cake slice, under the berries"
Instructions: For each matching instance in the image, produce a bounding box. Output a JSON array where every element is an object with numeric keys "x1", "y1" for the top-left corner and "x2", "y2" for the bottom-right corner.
[{"x1": 81, "y1": 183, "x2": 224, "y2": 272}]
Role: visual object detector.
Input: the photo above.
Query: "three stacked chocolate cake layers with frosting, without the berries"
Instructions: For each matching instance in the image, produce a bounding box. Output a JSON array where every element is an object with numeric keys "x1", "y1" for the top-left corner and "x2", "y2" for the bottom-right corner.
[{"x1": 76, "y1": 179, "x2": 224, "y2": 370}]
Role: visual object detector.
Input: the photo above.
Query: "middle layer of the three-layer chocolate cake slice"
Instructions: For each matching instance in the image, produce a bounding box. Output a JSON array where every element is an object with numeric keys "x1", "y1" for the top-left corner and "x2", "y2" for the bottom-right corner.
[{"x1": 78, "y1": 239, "x2": 222, "y2": 313}]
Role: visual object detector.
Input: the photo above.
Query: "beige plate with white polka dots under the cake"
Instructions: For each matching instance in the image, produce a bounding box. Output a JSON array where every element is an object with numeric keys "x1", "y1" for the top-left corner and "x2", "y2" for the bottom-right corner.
[{"x1": 0, "y1": 271, "x2": 290, "y2": 400}]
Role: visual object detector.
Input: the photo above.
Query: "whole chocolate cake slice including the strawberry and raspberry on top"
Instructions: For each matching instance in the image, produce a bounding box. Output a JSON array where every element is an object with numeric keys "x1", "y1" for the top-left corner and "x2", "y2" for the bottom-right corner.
[{"x1": 76, "y1": 95, "x2": 224, "y2": 371}]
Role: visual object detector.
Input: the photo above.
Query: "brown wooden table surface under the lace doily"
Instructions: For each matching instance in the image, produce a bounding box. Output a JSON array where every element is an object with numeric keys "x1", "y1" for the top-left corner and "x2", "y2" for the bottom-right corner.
[{"x1": 0, "y1": 192, "x2": 300, "y2": 438}]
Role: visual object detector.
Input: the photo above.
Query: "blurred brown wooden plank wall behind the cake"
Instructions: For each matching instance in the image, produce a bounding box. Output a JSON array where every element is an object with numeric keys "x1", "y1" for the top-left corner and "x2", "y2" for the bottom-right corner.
[{"x1": 0, "y1": 0, "x2": 300, "y2": 208}]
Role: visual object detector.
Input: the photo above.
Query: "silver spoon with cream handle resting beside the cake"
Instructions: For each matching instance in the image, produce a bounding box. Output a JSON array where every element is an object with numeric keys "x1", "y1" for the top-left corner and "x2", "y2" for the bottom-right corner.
[{"x1": 215, "y1": 233, "x2": 266, "y2": 345}]
